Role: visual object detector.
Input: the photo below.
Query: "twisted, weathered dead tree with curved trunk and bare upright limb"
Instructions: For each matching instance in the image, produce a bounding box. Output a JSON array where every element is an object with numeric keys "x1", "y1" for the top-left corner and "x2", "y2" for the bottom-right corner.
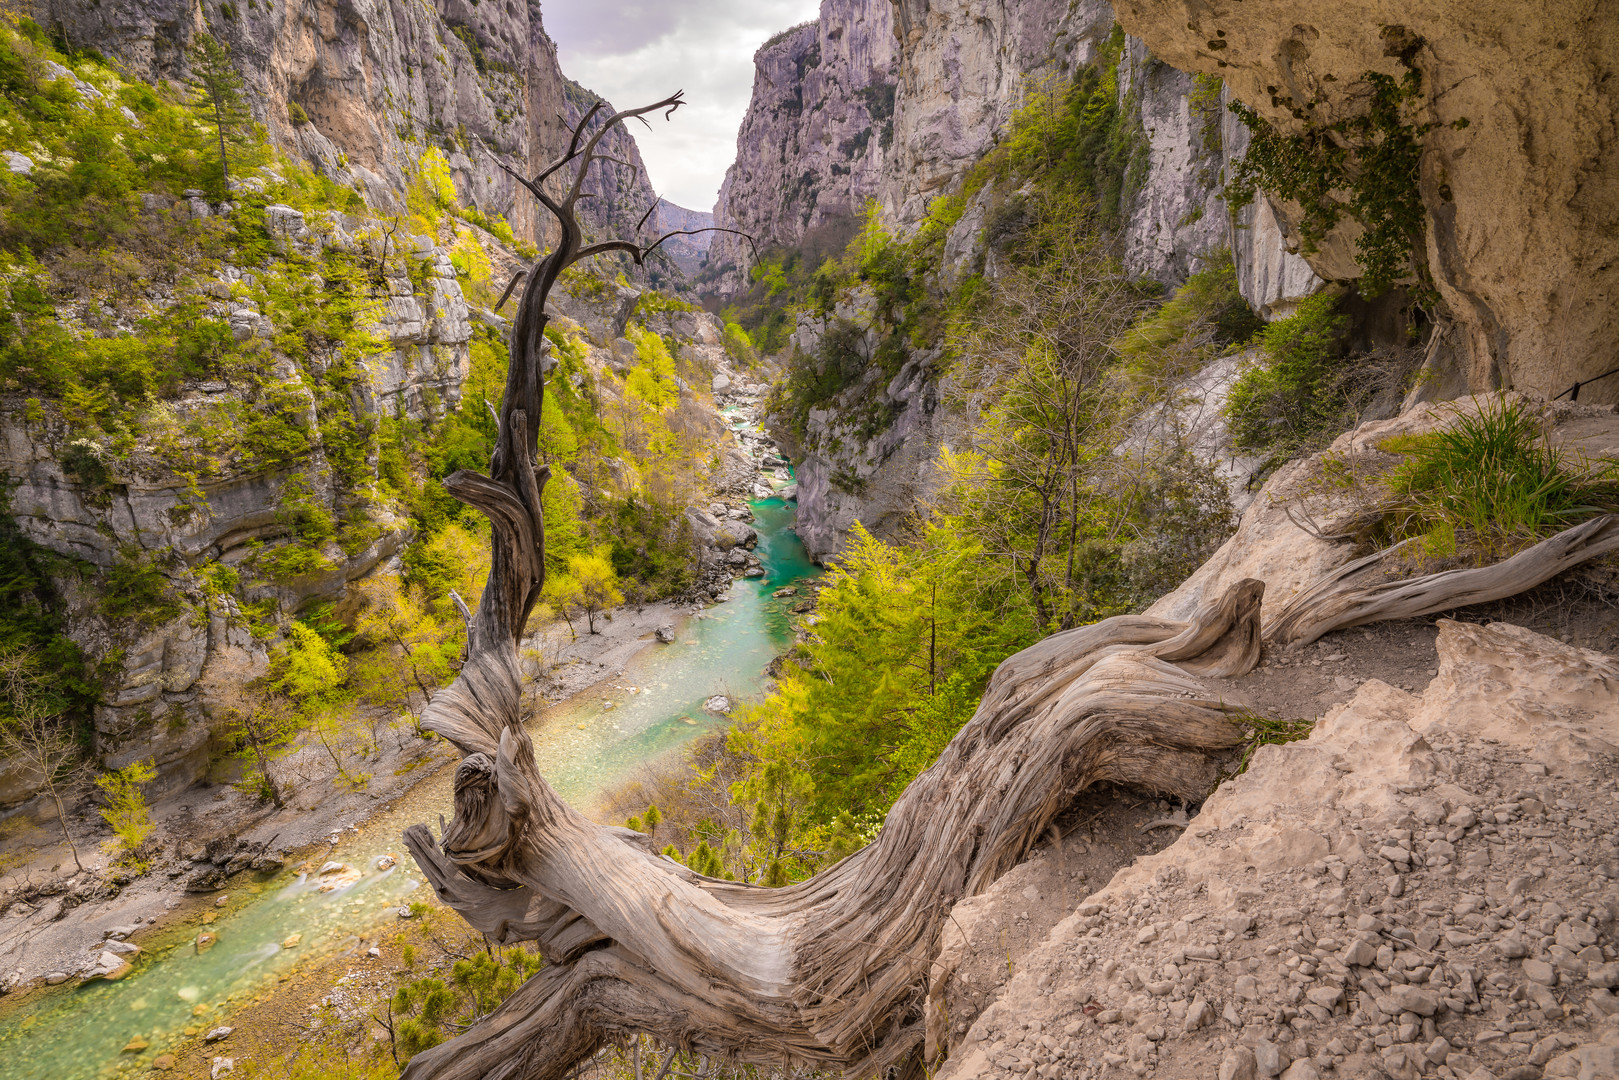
[{"x1": 405, "y1": 94, "x2": 1263, "y2": 1080}]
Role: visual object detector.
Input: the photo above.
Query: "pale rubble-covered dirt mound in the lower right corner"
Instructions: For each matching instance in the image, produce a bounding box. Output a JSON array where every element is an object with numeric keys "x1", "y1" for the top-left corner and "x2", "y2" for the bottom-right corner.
[{"x1": 929, "y1": 622, "x2": 1619, "y2": 1080}]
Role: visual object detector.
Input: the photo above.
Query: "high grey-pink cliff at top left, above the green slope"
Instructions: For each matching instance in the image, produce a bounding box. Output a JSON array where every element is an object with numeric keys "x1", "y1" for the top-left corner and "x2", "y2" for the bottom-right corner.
[{"x1": 34, "y1": 0, "x2": 663, "y2": 259}]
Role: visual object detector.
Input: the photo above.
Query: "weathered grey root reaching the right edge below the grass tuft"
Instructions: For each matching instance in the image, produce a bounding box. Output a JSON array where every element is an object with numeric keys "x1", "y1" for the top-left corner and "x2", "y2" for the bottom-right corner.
[{"x1": 1264, "y1": 513, "x2": 1619, "y2": 644}]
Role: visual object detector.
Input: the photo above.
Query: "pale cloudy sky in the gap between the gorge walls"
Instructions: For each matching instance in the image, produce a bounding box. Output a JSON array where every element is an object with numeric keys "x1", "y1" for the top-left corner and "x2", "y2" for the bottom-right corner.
[{"x1": 542, "y1": 0, "x2": 821, "y2": 210}]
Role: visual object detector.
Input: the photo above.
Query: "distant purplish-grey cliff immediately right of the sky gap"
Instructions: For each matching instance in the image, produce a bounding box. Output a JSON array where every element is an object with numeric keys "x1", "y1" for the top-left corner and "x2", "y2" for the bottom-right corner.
[{"x1": 706, "y1": 0, "x2": 899, "y2": 295}]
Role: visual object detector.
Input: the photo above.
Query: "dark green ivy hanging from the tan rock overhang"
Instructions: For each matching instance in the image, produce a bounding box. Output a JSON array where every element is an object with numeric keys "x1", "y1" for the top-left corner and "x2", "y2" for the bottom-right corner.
[{"x1": 1226, "y1": 68, "x2": 1444, "y2": 296}]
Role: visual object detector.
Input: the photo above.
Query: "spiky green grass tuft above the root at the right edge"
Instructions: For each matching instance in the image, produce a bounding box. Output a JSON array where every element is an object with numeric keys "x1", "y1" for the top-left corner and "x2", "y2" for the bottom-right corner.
[{"x1": 1381, "y1": 400, "x2": 1619, "y2": 563}]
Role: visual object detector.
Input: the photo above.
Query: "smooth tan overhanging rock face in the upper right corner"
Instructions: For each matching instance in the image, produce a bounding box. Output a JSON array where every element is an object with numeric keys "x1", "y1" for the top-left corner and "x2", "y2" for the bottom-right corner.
[{"x1": 1119, "y1": 0, "x2": 1619, "y2": 402}]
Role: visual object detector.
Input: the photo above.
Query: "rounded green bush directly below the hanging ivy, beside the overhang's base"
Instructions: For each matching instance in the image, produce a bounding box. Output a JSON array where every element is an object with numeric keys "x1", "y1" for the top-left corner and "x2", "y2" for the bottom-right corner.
[{"x1": 1226, "y1": 293, "x2": 1352, "y2": 457}]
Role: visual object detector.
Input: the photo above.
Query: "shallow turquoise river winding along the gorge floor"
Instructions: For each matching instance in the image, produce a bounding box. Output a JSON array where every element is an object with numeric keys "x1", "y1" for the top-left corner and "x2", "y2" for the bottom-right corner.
[{"x1": 0, "y1": 499, "x2": 819, "y2": 1080}]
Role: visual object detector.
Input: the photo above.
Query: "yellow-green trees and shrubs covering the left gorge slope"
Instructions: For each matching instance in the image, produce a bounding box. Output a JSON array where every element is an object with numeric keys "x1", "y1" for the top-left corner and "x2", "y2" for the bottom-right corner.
[{"x1": 0, "y1": 18, "x2": 714, "y2": 819}]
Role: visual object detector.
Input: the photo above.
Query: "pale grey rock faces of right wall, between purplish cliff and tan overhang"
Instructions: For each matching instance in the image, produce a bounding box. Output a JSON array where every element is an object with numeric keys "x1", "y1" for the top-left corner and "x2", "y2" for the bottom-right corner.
[{"x1": 764, "y1": 0, "x2": 1323, "y2": 557}]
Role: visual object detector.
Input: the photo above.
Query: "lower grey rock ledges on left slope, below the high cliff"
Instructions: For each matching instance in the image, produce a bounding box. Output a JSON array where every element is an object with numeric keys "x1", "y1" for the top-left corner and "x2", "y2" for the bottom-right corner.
[{"x1": 0, "y1": 190, "x2": 473, "y2": 806}]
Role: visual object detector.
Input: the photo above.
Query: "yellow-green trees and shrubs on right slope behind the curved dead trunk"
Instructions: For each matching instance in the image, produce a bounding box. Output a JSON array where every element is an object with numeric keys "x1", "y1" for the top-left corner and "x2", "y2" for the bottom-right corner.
[{"x1": 615, "y1": 46, "x2": 1258, "y2": 884}]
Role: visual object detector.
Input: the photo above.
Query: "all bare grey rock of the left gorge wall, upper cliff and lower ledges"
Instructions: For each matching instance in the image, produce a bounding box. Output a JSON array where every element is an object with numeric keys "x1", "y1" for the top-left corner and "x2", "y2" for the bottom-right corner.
[{"x1": 0, "y1": 0, "x2": 704, "y2": 808}]
